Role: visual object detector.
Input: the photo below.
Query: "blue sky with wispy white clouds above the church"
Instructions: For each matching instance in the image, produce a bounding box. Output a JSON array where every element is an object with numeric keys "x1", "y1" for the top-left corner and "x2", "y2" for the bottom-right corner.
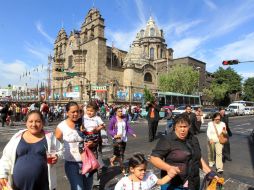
[{"x1": 0, "y1": 0, "x2": 254, "y2": 87}]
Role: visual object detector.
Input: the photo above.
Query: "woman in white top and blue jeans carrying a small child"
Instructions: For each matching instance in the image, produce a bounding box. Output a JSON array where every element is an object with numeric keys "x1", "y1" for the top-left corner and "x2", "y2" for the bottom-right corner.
[{"x1": 55, "y1": 102, "x2": 93, "y2": 190}]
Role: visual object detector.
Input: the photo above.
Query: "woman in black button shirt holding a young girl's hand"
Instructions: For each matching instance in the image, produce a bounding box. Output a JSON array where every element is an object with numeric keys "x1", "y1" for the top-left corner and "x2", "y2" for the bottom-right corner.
[{"x1": 150, "y1": 115, "x2": 215, "y2": 190}]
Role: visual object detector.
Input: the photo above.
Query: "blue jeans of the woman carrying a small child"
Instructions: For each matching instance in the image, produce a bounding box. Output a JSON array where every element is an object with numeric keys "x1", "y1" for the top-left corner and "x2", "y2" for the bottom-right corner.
[{"x1": 64, "y1": 161, "x2": 93, "y2": 190}]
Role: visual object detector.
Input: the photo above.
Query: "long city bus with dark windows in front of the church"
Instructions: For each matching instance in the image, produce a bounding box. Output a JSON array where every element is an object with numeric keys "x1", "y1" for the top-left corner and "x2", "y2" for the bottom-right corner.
[{"x1": 156, "y1": 92, "x2": 201, "y2": 109}]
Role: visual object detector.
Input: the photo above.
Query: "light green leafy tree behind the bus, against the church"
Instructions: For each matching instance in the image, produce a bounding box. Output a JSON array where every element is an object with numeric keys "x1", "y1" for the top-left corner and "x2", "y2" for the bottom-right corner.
[{"x1": 159, "y1": 65, "x2": 199, "y2": 94}]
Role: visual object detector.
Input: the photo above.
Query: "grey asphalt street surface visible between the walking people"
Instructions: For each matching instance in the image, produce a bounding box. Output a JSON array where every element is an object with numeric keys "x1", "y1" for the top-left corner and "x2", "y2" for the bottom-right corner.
[{"x1": 0, "y1": 116, "x2": 254, "y2": 190}]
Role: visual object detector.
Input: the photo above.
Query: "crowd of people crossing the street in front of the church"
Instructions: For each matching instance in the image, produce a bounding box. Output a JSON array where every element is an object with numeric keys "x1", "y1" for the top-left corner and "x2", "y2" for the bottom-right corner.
[{"x1": 0, "y1": 101, "x2": 232, "y2": 190}]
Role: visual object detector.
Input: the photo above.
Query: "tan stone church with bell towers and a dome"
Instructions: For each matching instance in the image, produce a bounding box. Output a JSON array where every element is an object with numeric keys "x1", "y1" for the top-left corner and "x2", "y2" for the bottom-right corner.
[{"x1": 51, "y1": 8, "x2": 206, "y2": 103}]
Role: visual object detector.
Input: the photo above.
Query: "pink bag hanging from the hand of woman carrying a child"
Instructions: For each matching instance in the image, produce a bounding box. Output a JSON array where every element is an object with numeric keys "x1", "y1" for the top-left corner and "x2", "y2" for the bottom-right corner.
[{"x1": 81, "y1": 146, "x2": 100, "y2": 175}]
